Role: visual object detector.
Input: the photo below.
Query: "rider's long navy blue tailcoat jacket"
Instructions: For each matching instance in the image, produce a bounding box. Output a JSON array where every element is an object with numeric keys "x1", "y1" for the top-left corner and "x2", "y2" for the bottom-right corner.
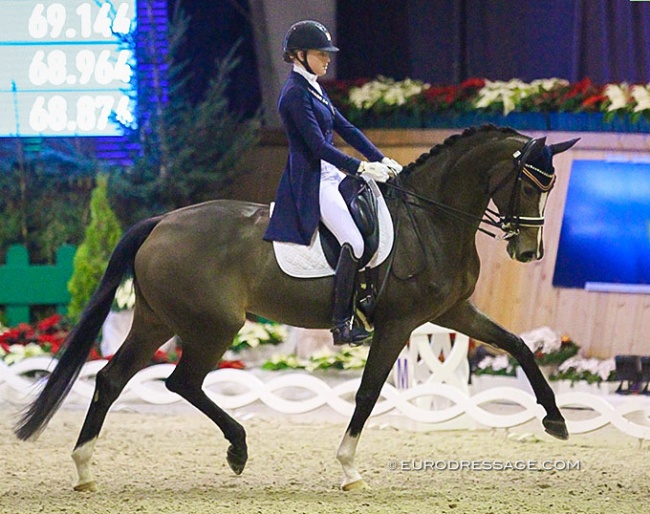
[{"x1": 264, "y1": 71, "x2": 384, "y2": 245}]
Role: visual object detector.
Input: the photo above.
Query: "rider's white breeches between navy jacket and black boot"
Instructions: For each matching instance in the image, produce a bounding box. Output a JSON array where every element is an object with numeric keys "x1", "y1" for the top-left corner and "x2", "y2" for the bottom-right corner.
[{"x1": 319, "y1": 168, "x2": 363, "y2": 259}]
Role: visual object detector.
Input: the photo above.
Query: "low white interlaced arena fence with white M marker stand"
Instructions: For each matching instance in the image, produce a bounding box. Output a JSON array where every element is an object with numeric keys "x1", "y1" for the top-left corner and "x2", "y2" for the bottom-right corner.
[{"x1": 0, "y1": 325, "x2": 650, "y2": 440}]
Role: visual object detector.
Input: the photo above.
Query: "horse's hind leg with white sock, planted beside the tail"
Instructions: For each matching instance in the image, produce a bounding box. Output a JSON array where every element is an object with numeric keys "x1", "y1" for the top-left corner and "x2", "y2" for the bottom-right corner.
[{"x1": 72, "y1": 303, "x2": 173, "y2": 491}]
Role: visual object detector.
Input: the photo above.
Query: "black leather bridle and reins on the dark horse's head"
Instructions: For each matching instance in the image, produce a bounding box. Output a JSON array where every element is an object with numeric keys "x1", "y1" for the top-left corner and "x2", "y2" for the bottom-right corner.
[{"x1": 385, "y1": 139, "x2": 556, "y2": 240}]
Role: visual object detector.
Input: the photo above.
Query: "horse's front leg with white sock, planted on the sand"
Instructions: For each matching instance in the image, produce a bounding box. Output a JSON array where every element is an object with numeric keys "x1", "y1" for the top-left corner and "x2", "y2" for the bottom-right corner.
[{"x1": 336, "y1": 327, "x2": 410, "y2": 491}]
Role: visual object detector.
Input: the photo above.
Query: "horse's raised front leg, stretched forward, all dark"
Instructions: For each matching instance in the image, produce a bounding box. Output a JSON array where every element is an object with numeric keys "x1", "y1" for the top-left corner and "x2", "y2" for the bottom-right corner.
[{"x1": 431, "y1": 300, "x2": 569, "y2": 439}]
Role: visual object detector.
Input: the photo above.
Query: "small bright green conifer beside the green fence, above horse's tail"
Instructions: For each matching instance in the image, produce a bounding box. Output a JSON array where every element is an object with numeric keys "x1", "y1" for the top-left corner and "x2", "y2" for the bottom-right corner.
[{"x1": 68, "y1": 175, "x2": 122, "y2": 320}]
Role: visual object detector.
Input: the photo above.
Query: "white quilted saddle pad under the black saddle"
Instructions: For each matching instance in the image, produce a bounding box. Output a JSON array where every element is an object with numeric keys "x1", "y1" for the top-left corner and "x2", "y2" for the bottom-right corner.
[{"x1": 273, "y1": 183, "x2": 394, "y2": 278}]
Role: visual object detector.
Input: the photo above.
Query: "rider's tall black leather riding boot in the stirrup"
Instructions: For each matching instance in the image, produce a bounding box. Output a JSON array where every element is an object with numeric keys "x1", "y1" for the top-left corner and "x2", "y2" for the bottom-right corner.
[{"x1": 331, "y1": 244, "x2": 372, "y2": 345}]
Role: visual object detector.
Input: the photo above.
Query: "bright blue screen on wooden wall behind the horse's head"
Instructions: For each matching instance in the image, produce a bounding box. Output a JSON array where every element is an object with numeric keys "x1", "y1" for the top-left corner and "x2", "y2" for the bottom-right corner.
[{"x1": 553, "y1": 160, "x2": 650, "y2": 291}]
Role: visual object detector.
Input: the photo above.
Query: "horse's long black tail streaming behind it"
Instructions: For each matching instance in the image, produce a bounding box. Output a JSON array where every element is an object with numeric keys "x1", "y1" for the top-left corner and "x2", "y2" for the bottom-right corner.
[{"x1": 14, "y1": 217, "x2": 161, "y2": 440}]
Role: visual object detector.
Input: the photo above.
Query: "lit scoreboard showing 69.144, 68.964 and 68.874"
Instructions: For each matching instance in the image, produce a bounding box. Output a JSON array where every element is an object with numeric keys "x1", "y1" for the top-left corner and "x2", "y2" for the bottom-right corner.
[{"x1": 0, "y1": 0, "x2": 136, "y2": 137}]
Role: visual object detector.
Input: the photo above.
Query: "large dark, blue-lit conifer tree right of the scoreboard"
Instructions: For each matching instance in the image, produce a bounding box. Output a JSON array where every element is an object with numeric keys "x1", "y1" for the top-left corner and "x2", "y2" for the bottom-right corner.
[{"x1": 109, "y1": 3, "x2": 261, "y2": 226}]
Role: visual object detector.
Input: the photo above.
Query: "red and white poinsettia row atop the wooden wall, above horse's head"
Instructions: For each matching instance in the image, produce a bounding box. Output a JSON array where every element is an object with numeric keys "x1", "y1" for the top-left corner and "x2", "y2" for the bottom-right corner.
[{"x1": 324, "y1": 76, "x2": 650, "y2": 132}]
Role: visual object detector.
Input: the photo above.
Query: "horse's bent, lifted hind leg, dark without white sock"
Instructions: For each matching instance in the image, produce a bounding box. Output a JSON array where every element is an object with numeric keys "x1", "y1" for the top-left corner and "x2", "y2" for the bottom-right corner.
[{"x1": 166, "y1": 319, "x2": 248, "y2": 475}]
